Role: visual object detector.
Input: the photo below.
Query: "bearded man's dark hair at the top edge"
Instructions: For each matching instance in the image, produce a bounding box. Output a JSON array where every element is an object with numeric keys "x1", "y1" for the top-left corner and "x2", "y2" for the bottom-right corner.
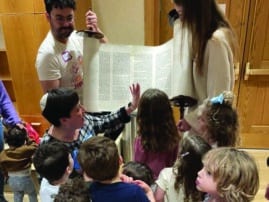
[{"x1": 44, "y1": 0, "x2": 76, "y2": 13}]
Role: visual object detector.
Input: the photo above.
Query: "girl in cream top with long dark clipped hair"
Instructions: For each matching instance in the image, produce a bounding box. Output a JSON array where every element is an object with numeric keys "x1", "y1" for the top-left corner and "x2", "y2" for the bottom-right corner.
[{"x1": 154, "y1": 135, "x2": 211, "y2": 202}]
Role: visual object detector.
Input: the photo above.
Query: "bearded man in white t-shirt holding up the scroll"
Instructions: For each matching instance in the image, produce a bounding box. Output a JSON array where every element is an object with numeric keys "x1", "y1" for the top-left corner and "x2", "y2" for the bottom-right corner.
[{"x1": 36, "y1": 0, "x2": 107, "y2": 100}]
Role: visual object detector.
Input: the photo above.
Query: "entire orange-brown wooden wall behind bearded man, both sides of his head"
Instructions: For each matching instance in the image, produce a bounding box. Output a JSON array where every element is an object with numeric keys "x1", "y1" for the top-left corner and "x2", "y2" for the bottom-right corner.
[{"x1": 0, "y1": 0, "x2": 91, "y2": 135}]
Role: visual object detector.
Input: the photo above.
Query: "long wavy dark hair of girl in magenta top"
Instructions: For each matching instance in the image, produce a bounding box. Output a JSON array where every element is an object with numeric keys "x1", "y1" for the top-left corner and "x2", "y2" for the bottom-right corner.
[{"x1": 137, "y1": 88, "x2": 180, "y2": 152}]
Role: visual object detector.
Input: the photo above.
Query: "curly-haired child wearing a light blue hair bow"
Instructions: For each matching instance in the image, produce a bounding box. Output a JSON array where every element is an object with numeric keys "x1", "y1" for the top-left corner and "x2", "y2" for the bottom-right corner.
[{"x1": 181, "y1": 91, "x2": 239, "y2": 147}]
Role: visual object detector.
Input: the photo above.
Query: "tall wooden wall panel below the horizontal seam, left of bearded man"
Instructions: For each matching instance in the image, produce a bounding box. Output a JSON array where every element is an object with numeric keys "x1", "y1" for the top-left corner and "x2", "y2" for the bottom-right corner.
[{"x1": 2, "y1": 14, "x2": 41, "y2": 114}]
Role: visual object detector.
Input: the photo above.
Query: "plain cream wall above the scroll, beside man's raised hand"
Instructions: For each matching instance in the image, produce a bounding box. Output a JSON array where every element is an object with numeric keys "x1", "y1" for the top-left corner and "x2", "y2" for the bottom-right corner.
[{"x1": 92, "y1": 0, "x2": 144, "y2": 45}]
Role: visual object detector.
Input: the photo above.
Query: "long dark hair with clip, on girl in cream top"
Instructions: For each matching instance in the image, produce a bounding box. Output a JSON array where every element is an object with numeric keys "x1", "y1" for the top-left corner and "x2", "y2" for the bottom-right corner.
[{"x1": 173, "y1": 135, "x2": 211, "y2": 201}]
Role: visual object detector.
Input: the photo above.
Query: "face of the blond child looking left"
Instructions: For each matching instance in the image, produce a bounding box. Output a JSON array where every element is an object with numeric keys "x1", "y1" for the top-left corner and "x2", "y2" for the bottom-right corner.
[{"x1": 195, "y1": 166, "x2": 217, "y2": 195}]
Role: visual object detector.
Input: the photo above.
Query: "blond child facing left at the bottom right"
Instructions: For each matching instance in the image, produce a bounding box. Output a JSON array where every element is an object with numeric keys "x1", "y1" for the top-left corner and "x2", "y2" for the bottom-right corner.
[{"x1": 196, "y1": 147, "x2": 259, "y2": 202}]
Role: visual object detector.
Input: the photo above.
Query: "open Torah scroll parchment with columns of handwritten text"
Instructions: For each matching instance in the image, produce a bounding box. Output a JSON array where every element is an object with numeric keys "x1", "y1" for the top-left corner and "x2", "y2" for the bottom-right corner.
[{"x1": 83, "y1": 22, "x2": 191, "y2": 111}]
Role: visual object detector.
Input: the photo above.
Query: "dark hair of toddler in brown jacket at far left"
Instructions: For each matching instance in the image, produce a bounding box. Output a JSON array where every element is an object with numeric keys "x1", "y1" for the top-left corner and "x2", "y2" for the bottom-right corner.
[{"x1": 5, "y1": 126, "x2": 28, "y2": 147}]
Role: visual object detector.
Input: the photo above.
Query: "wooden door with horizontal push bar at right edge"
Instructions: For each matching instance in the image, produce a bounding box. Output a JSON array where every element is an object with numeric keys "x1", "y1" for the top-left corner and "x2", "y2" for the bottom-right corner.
[{"x1": 238, "y1": 0, "x2": 269, "y2": 148}]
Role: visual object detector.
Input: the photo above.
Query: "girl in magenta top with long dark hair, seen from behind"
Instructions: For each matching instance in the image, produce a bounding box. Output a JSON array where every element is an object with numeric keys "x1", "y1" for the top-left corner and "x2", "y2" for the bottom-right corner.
[{"x1": 134, "y1": 89, "x2": 180, "y2": 179}]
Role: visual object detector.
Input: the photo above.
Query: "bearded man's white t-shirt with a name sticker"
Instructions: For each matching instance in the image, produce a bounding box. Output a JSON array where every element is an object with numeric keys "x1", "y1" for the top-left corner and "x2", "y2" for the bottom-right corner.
[{"x1": 36, "y1": 31, "x2": 83, "y2": 97}]
